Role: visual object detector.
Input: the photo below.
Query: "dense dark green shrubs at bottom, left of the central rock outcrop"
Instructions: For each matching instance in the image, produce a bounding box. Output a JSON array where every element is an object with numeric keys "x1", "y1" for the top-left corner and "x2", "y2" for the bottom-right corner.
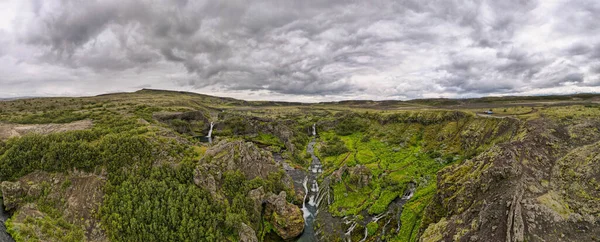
[{"x1": 101, "y1": 164, "x2": 227, "y2": 241}]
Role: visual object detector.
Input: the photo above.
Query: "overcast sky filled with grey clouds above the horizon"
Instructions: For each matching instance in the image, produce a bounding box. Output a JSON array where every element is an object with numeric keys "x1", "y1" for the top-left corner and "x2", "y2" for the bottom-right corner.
[{"x1": 0, "y1": 0, "x2": 600, "y2": 102}]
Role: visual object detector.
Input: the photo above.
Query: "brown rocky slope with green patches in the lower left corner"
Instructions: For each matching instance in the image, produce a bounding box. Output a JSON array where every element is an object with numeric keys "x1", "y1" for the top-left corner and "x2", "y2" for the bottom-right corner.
[{"x1": 0, "y1": 172, "x2": 107, "y2": 241}]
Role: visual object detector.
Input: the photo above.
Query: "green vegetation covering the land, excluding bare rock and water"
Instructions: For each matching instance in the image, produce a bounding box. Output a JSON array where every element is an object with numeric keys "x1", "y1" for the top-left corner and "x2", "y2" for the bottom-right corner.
[{"x1": 0, "y1": 90, "x2": 600, "y2": 241}]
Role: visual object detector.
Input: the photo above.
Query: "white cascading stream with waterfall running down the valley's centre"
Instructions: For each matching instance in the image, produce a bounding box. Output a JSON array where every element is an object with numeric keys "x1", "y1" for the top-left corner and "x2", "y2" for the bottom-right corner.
[{"x1": 298, "y1": 124, "x2": 323, "y2": 242}]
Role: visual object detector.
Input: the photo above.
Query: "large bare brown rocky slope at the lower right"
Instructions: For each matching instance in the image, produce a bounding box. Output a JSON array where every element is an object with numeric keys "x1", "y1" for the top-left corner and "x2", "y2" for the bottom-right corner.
[{"x1": 420, "y1": 118, "x2": 600, "y2": 242}]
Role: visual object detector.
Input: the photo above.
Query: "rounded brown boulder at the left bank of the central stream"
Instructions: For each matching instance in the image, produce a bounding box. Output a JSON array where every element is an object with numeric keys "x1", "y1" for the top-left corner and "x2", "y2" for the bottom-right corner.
[{"x1": 265, "y1": 192, "x2": 304, "y2": 240}]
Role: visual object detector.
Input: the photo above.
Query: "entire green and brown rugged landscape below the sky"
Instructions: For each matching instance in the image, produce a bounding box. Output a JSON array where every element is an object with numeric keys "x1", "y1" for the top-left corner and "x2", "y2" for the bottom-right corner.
[{"x1": 0, "y1": 90, "x2": 600, "y2": 242}]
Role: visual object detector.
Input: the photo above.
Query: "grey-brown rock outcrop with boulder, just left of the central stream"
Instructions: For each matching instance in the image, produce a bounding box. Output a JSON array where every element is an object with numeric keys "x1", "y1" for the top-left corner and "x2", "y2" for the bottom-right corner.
[{"x1": 194, "y1": 140, "x2": 304, "y2": 240}]
